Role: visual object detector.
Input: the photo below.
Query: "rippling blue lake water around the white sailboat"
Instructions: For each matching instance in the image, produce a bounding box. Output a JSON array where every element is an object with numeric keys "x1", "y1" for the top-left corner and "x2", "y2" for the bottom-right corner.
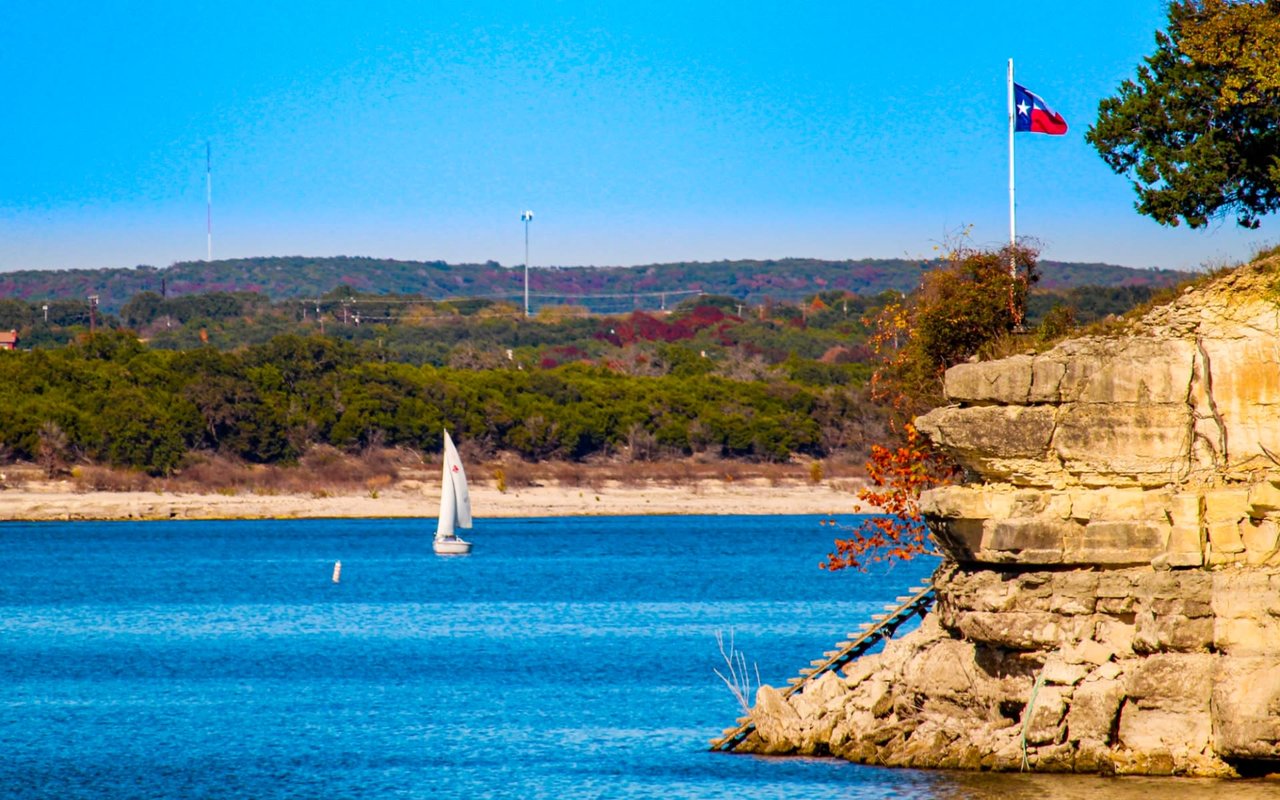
[{"x1": 0, "y1": 516, "x2": 1280, "y2": 800}]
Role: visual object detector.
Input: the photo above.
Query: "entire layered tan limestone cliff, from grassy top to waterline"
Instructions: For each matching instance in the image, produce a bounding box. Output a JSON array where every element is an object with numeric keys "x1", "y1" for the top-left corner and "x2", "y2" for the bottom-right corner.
[{"x1": 744, "y1": 264, "x2": 1280, "y2": 776}]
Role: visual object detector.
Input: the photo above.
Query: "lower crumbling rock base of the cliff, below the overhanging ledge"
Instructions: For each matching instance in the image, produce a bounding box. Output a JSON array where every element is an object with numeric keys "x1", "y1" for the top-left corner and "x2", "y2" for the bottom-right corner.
[{"x1": 739, "y1": 564, "x2": 1280, "y2": 777}]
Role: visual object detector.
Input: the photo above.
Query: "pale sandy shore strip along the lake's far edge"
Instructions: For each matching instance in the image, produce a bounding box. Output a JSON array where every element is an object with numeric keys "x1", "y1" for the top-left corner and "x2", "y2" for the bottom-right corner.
[{"x1": 0, "y1": 480, "x2": 870, "y2": 521}]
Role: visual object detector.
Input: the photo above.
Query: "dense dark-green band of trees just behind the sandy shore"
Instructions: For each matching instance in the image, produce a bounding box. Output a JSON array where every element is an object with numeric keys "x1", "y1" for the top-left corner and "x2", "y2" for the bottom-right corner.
[{"x1": 0, "y1": 333, "x2": 876, "y2": 475}]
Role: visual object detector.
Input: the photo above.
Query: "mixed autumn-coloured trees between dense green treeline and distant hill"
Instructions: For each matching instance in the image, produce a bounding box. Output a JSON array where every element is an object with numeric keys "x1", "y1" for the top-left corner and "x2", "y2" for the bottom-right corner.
[{"x1": 0, "y1": 285, "x2": 1155, "y2": 385}]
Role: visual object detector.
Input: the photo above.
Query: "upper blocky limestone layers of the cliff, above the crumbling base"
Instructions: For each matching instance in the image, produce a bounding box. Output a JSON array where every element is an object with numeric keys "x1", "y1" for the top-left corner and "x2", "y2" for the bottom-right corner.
[{"x1": 916, "y1": 265, "x2": 1280, "y2": 567}]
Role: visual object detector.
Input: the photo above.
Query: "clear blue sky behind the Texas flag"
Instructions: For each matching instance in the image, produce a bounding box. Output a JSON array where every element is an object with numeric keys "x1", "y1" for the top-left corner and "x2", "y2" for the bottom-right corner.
[{"x1": 0, "y1": 0, "x2": 1276, "y2": 270}]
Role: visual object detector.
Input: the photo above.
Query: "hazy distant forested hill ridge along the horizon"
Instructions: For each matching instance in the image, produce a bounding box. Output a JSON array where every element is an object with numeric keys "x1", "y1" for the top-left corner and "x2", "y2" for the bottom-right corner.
[{"x1": 0, "y1": 256, "x2": 1187, "y2": 311}]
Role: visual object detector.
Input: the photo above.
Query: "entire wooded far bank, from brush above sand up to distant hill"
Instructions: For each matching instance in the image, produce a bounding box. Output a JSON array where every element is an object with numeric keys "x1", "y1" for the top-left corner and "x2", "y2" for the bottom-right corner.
[{"x1": 0, "y1": 257, "x2": 1187, "y2": 475}]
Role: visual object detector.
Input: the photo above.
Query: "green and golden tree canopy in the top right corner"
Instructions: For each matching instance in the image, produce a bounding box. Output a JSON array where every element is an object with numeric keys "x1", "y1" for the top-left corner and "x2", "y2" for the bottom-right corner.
[{"x1": 1085, "y1": 0, "x2": 1280, "y2": 228}]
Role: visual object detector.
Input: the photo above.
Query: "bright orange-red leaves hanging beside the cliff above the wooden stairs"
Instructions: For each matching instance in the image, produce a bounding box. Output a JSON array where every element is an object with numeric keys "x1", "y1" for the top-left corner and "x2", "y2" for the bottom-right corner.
[{"x1": 819, "y1": 425, "x2": 954, "y2": 571}]
